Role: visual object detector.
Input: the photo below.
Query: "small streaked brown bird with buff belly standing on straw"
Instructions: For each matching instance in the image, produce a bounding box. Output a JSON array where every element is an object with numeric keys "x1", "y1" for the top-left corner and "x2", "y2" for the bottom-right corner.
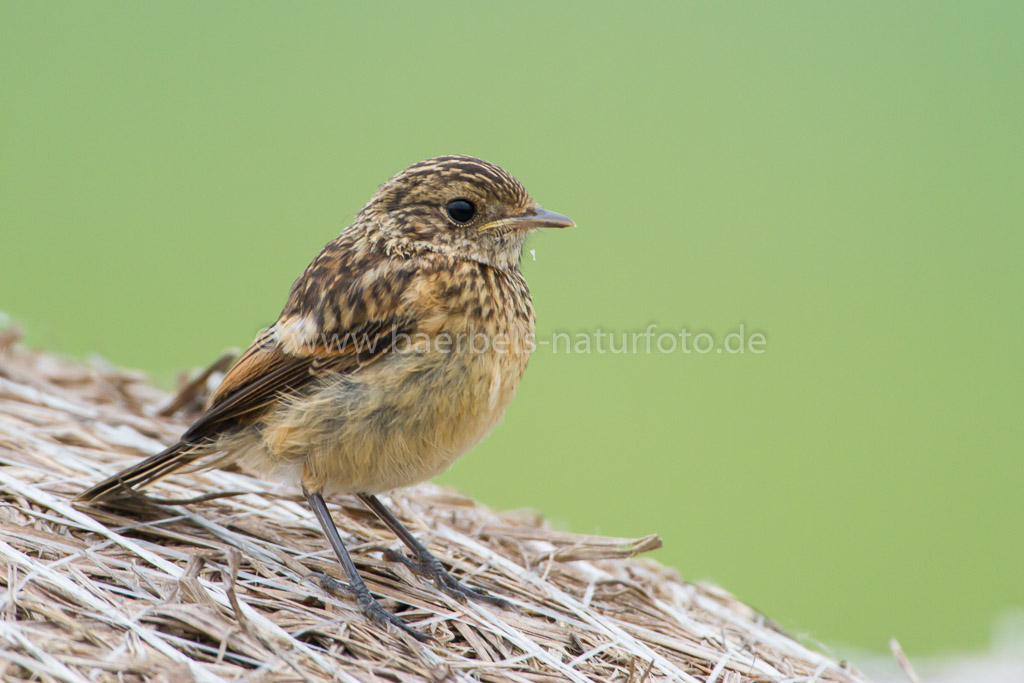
[{"x1": 78, "y1": 155, "x2": 575, "y2": 640}]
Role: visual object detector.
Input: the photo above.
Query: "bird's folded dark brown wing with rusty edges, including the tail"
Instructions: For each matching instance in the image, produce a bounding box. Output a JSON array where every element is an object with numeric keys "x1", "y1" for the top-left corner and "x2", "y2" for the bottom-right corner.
[{"x1": 79, "y1": 233, "x2": 417, "y2": 500}]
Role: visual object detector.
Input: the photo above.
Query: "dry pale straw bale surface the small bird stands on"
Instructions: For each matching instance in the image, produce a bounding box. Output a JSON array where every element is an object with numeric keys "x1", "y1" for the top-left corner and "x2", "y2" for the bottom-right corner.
[{"x1": 0, "y1": 332, "x2": 864, "y2": 683}]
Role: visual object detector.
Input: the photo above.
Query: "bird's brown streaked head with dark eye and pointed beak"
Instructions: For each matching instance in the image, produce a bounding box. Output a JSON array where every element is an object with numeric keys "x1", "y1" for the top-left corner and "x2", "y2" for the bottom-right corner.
[{"x1": 356, "y1": 156, "x2": 574, "y2": 268}]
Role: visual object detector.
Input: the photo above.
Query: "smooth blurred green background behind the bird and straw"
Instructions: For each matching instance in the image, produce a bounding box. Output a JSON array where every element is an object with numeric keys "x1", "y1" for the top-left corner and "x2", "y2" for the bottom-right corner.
[{"x1": 0, "y1": 1, "x2": 1024, "y2": 654}]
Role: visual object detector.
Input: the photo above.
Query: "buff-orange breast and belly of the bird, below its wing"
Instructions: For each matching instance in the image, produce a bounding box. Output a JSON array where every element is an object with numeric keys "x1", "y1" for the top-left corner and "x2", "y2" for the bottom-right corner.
[{"x1": 256, "y1": 270, "x2": 534, "y2": 493}]
